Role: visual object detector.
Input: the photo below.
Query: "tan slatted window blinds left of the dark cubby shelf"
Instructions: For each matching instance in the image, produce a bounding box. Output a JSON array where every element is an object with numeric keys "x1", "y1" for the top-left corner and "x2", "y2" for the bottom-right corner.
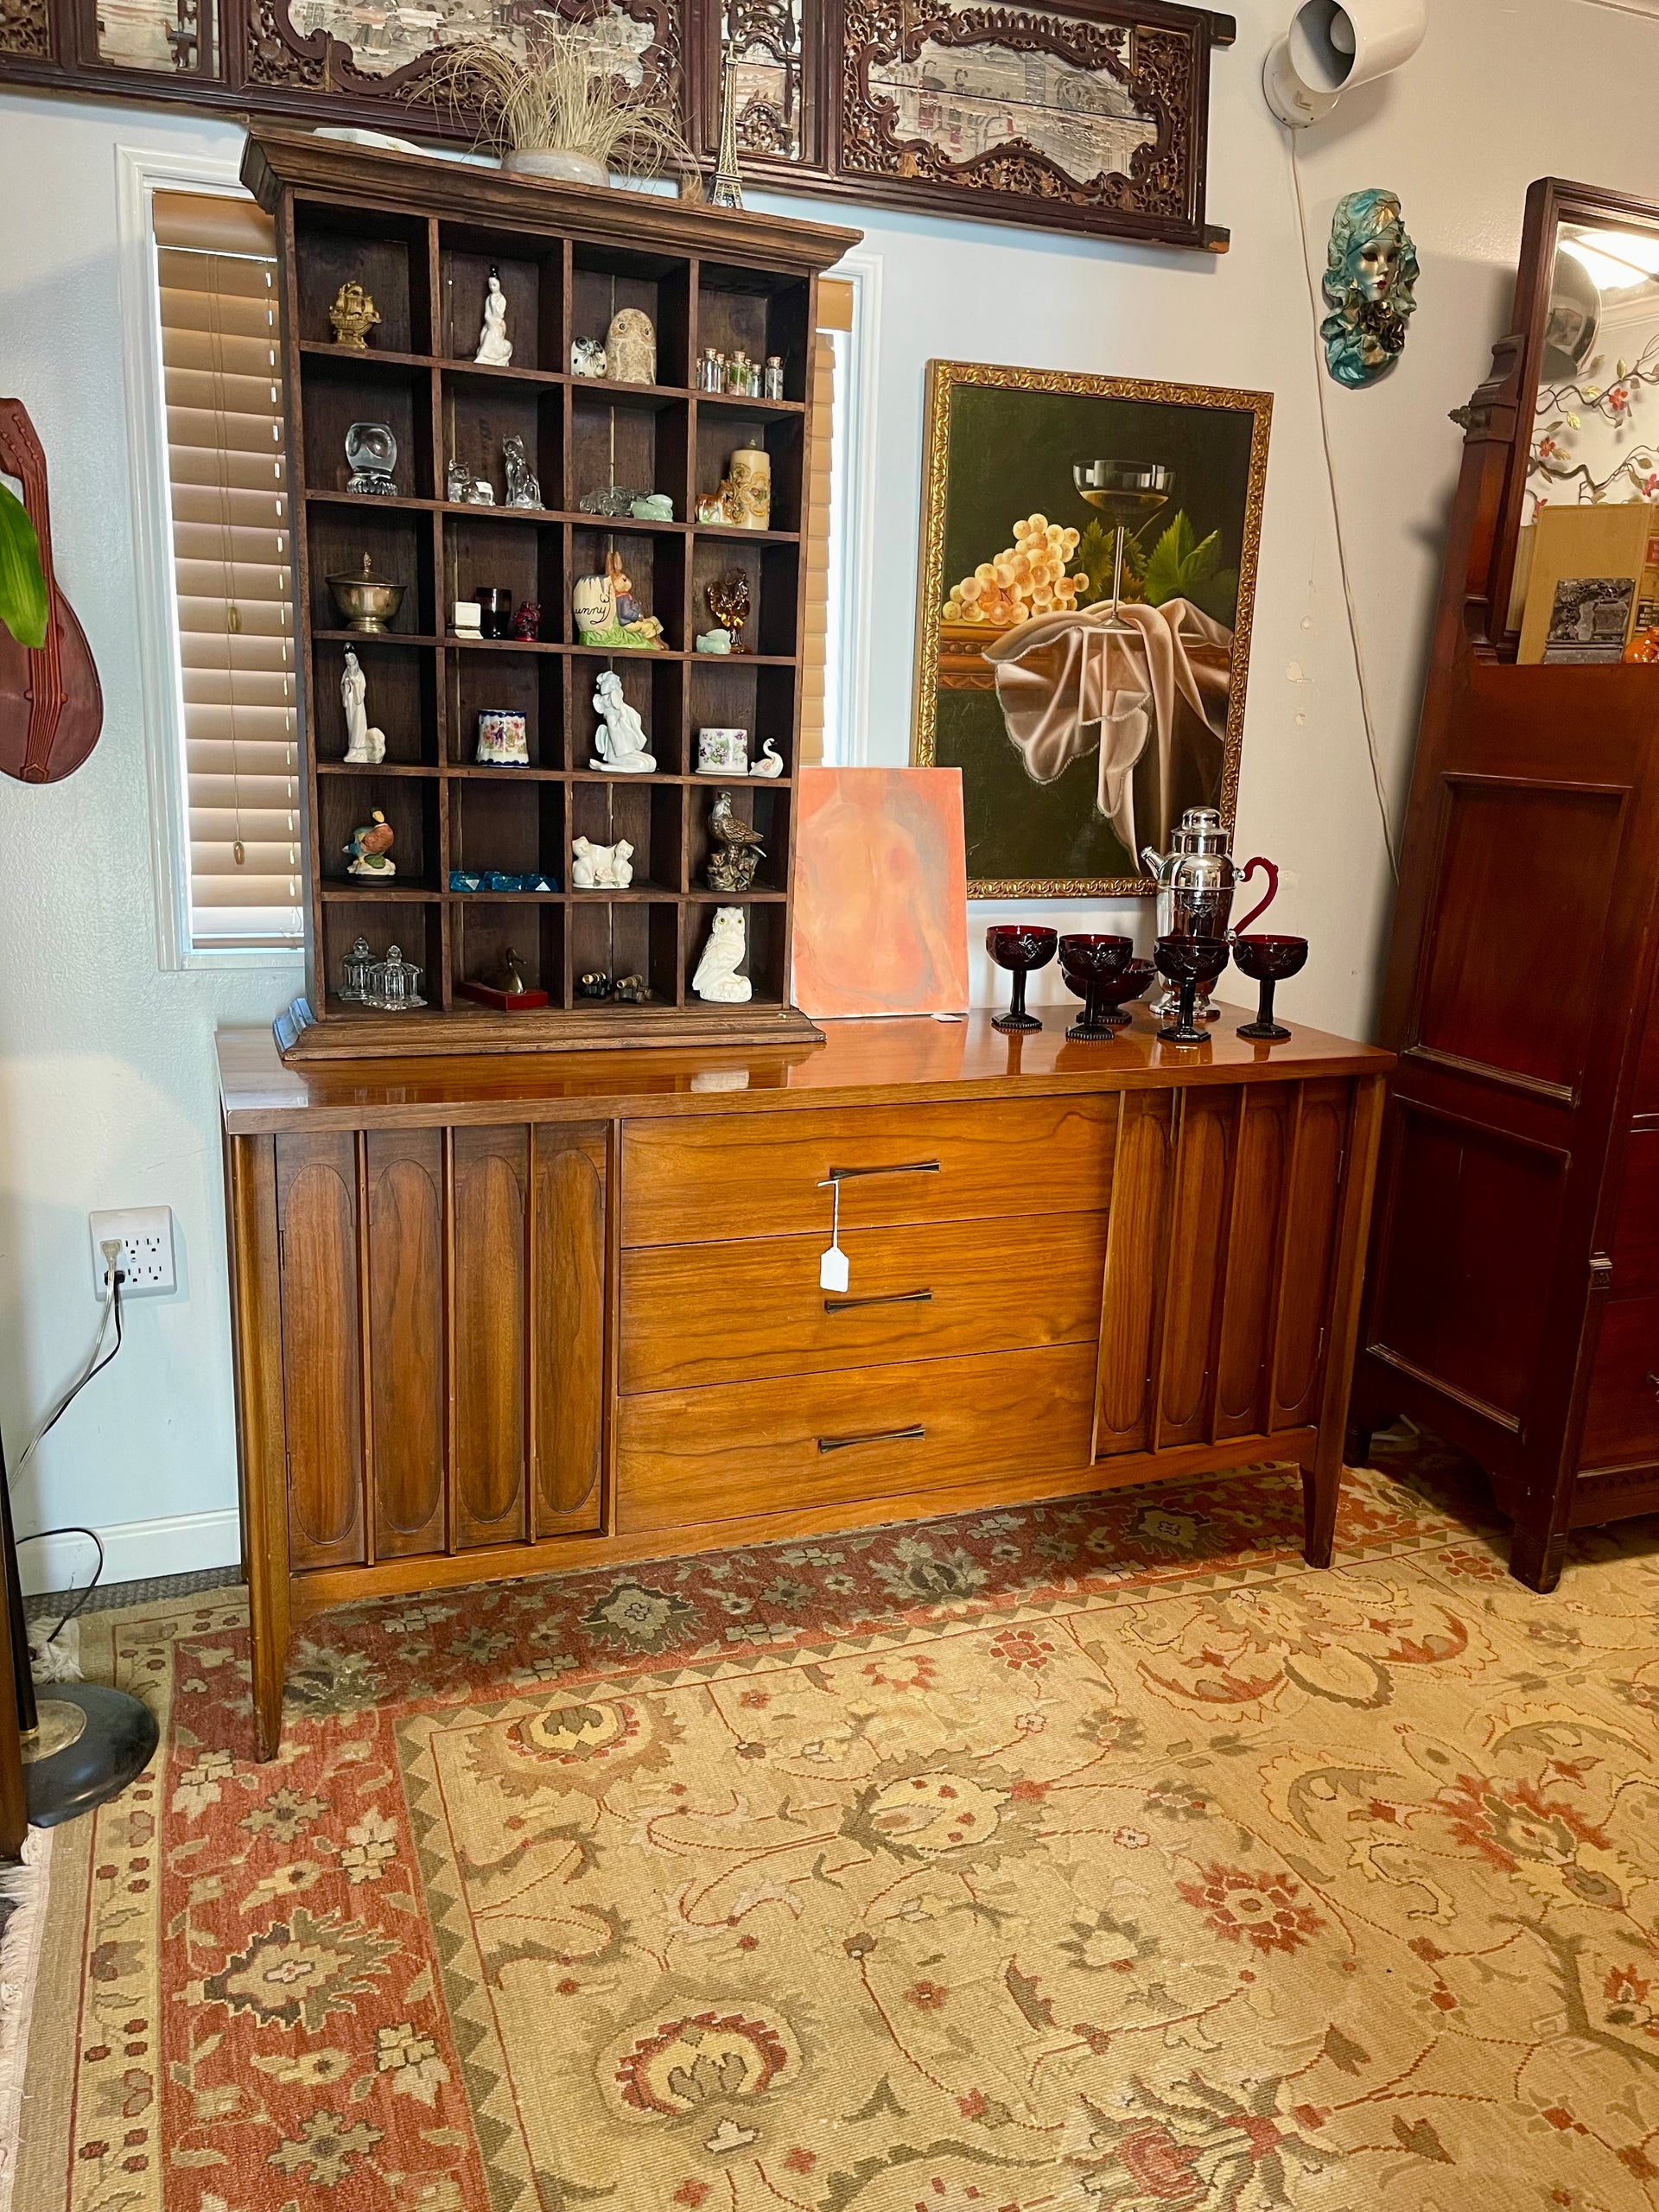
[{"x1": 153, "y1": 193, "x2": 303, "y2": 951}]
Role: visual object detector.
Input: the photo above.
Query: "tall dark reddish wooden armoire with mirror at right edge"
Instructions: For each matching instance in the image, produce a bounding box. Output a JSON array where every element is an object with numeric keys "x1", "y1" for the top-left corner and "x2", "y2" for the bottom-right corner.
[{"x1": 1354, "y1": 177, "x2": 1659, "y2": 1591}]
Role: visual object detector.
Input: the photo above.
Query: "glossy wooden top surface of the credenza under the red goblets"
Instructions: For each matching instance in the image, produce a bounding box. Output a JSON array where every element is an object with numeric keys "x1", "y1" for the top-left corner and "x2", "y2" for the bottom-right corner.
[{"x1": 217, "y1": 1007, "x2": 1394, "y2": 1137}]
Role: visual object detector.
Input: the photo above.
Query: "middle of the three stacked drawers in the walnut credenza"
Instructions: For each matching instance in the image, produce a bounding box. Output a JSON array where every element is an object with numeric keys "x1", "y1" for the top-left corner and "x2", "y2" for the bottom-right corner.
[{"x1": 617, "y1": 1201, "x2": 1106, "y2": 1391}]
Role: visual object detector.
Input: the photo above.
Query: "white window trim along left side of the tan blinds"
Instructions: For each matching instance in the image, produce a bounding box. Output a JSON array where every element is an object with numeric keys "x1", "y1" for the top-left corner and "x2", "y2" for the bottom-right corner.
[{"x1": 115, "y1": 146, "x2": 305, "y2": 976}]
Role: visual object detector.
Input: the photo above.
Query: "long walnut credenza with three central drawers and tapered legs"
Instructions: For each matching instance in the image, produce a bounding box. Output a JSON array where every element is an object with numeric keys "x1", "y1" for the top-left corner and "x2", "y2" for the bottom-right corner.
[{"x1": 219, "y1": 1013, "x2": 1389, "y2": 1757}]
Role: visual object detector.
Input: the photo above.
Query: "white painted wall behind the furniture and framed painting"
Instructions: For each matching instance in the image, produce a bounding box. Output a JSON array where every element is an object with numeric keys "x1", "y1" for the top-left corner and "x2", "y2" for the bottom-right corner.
[{"x1": 0, "y1": 0, "x2": 1659, "y2": 1573}]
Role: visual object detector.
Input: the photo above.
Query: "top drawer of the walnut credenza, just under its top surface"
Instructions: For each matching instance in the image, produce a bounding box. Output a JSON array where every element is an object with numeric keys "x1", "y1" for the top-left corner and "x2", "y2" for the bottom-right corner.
[{"x1": 621, "y1": 1095, "x2": 1117, "y2": 1249}]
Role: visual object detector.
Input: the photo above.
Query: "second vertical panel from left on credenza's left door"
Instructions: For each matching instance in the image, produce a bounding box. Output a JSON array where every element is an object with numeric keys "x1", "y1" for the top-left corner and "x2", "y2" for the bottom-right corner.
[{"x1": 365, "y1": 1128, "x2": 445, "y2": 1560}]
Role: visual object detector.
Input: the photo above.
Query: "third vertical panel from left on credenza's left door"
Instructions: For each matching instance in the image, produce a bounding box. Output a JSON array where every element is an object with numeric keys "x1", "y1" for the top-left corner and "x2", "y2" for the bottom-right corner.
[{"x1": 451, "y1": 1128, "x2": 529, "y2": 1548}]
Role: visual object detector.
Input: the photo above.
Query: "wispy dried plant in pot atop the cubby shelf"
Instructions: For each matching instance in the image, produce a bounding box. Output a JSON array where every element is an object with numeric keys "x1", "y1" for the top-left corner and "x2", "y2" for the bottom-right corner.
[{"x1": 420, "y1": 11, "x2": 702, "y2": 197}]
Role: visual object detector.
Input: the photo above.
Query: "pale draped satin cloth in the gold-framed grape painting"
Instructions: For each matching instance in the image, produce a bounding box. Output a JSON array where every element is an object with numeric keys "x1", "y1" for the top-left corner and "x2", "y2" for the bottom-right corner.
[{"x1": 984, "y1": 600, "x2": 1232, "y2": 852}]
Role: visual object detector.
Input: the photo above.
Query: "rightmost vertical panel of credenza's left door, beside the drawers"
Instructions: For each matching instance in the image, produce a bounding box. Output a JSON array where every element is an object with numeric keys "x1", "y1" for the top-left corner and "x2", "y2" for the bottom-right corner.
[{"x1": 531, "y1": 1123, "x2": 606, "y2": 1537}]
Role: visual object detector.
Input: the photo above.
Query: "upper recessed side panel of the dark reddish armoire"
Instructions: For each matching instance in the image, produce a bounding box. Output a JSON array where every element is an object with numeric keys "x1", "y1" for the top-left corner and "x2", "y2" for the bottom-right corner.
[{"x1": 1409, "y1": 774, "x2": 1626, "y2": 1095}]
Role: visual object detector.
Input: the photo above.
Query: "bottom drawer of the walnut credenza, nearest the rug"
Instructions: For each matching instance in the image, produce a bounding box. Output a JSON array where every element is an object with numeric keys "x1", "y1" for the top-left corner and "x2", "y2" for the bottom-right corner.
[{"x1": 617, "y1": 1344, "x2": 1095, "y2": 1535}]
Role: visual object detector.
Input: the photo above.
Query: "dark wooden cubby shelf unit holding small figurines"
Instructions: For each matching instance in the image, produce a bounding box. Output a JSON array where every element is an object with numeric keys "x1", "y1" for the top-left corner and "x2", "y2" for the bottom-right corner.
[{"x1": 244, "y1": 130, "x2": 858, "y2": 1058}]
